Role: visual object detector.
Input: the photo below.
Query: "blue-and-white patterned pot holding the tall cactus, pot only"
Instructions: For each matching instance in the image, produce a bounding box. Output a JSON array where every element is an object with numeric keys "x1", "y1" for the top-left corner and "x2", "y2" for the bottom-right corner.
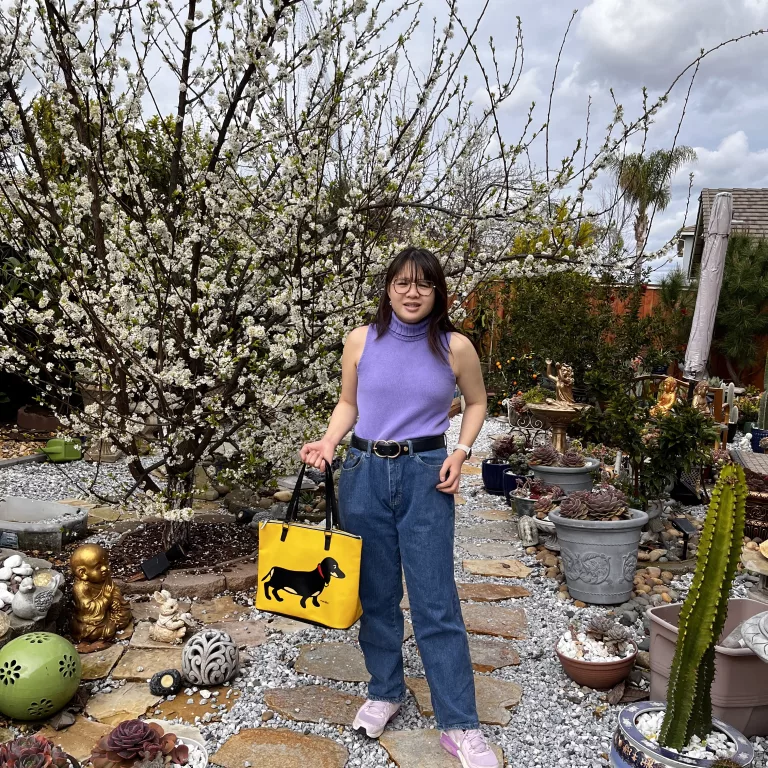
[{"x1": 611, "y1": 701, "x2": 755, "y2": 768}]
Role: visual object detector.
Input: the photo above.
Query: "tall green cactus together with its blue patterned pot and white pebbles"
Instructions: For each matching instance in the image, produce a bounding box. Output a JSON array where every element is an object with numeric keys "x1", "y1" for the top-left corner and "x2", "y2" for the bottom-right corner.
[{"x1": 611, "y1": 466, "x2": 760, "y2": 768}]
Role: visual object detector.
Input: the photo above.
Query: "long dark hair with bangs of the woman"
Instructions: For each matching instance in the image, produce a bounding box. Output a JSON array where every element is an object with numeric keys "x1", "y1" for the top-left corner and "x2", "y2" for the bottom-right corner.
[{"x1": 375, "y1": 247, "x2": 459, "y2": 363}]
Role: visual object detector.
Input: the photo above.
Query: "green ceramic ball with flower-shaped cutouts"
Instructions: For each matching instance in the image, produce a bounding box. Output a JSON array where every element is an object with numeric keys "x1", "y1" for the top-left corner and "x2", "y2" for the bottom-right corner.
[{"x1": 0, "y1": 632, "x2": 82, "y2": 720}]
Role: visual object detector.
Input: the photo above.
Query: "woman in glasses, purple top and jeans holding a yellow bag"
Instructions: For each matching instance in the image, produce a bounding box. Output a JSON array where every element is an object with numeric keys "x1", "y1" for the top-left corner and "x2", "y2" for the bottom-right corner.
[{"x1": 300, "y1": 248, "x2": 498, "y2": 768}]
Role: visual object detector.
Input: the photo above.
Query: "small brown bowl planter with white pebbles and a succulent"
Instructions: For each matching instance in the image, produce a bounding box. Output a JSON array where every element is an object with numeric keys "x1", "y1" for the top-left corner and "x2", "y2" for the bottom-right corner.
[{"x1": 555, "y1": 616, "x2": 637, "y2": 690}]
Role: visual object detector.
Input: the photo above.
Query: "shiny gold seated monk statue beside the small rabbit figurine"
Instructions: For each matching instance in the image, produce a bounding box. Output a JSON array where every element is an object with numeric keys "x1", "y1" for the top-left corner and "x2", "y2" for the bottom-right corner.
[{"x1": 69, "y1": 544, "x2": 132, "y2": 642}]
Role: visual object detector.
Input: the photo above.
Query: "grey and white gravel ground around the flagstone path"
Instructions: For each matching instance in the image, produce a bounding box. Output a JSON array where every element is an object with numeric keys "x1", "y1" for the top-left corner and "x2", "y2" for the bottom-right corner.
[{"x1": 0, "y1": 415, "x2": 768, "y2": 768}]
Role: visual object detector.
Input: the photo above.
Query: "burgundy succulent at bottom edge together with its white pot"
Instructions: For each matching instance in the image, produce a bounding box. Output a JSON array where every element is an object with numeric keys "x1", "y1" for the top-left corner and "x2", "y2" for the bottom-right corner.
[{"x1": 90, "y1": 720, "x2": 208, "y2": 768}]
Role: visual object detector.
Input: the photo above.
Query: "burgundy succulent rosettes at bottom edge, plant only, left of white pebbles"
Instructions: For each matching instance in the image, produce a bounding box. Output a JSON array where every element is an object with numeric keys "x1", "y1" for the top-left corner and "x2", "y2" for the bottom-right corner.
[{"x1": 91, "y1": 720, "x2": 189, "y2": 768}]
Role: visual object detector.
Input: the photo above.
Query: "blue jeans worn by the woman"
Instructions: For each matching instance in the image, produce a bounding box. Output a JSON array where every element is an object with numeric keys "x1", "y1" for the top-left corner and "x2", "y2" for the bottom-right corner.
[{"x1": 339, "y1": 436, "x2": 479, "y2": 730}]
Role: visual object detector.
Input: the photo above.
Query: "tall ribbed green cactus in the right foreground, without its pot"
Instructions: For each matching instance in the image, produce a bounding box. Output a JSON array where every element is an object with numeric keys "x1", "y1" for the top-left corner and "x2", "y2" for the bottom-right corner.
[{"x1": 659, "y1": 466, "x2": 747, "y2": 750}]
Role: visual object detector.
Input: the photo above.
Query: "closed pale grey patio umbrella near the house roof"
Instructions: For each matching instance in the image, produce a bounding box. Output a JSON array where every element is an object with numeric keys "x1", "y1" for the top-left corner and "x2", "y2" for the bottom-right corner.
[{"x1": 684, "y1": 192, "x2": 733, "y2": 379}]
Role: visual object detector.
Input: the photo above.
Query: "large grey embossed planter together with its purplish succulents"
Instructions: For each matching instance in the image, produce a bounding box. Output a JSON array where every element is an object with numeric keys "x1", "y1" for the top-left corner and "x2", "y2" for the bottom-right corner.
[{"x1": 549, "y1": 483, "x2": 648, "y2": 605}]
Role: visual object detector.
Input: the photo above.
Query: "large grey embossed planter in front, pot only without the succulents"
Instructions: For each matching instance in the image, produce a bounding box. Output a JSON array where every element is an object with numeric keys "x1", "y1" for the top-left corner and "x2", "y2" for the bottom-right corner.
[{"x1": 549, "y1": 508, "x2": 648, "y2": 605}]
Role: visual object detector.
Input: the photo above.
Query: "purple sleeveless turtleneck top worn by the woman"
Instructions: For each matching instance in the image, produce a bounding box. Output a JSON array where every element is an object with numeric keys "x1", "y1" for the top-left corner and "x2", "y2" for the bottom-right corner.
[{"x1": 355, "y1": 312, "x2": 456, "y2": 441}]
